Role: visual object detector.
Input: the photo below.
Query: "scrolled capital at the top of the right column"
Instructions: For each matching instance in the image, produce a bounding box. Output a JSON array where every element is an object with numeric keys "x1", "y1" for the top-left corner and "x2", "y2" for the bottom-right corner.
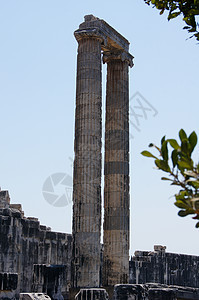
[{"x1": 103, "y1": 50, "x2": 134, "y2": 68}]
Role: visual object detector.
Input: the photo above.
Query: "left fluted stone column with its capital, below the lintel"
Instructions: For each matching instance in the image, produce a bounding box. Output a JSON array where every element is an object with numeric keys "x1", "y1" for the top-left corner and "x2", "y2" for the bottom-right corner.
[{"x1": 73, "y1": 29, "x2": 102, "y2": 287}]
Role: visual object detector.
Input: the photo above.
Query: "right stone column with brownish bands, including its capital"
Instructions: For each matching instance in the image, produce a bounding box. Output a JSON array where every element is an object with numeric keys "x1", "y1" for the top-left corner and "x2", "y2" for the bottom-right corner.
[{"x1": 103, "y1": 51, "x2": 132, "y2": 286}]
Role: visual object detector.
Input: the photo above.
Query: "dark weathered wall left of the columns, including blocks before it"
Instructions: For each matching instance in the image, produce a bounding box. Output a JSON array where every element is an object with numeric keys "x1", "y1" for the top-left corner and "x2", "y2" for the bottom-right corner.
[{"x1": 0, "y1": 191, "x2": 72, "y2": 299}]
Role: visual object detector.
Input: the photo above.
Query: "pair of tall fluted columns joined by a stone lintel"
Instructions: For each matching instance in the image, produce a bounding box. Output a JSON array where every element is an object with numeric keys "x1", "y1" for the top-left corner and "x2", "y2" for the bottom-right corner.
[{"x1": 73, "y1": 15, "x2": 133, "y2": 287}]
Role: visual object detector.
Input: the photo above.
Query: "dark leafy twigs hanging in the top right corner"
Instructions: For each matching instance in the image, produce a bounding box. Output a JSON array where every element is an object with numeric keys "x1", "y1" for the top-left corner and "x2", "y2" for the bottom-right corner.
[{"x1": 144, "y1": 0, "x2": 199, "y2": 41}]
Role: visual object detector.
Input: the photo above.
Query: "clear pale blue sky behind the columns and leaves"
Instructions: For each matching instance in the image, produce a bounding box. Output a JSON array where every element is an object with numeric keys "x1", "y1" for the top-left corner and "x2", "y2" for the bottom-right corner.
[{"x1": 0, "y1": 0, "x2": 199, "y2": 255}]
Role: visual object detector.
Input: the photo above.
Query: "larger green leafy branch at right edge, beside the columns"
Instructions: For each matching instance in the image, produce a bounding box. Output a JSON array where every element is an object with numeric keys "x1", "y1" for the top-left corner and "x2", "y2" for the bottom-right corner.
[{"x1": 141, "y1": 129, "x2": 199, "y2": 228}]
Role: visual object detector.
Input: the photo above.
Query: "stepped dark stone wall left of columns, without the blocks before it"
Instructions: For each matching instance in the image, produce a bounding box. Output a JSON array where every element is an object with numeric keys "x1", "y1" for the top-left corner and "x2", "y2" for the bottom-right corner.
[{"x1": 0, "y1": 191, "x2": 72, "y2": 293}]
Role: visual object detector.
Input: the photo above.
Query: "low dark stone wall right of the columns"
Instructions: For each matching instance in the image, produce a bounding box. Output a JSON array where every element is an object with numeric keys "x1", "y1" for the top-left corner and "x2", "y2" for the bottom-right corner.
[{"x1": 130, "y1": 246, "x2": 199, "y2": 288}]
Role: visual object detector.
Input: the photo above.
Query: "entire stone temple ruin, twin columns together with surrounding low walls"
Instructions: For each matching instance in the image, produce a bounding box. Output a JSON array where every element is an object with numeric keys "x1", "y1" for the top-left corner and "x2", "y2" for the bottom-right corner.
[{"x1": 0, "y1": 15, "x2": 199, "y2": 300}]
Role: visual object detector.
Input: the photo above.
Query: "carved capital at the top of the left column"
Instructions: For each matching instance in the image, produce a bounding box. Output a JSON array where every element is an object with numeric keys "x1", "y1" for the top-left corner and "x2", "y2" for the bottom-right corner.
[{"x1": 74, "y1": 28, "x2": 107, "y2": 45}]
